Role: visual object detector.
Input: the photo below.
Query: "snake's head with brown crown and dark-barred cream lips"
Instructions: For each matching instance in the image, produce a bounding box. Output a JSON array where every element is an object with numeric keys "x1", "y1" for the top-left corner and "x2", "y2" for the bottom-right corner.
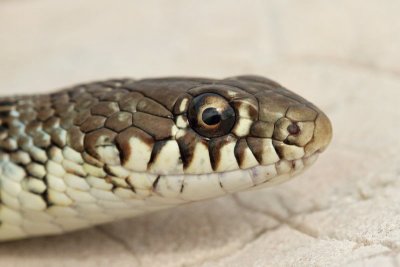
[{"x1": 76, "y1": 76, "x2": 332, "y2": 201}]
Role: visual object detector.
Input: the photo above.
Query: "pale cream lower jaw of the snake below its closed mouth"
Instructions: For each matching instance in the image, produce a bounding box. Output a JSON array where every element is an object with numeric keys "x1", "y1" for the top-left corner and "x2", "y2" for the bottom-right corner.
[{"x1": 152, "y1": 152, "x2": 320, "y2": 203}]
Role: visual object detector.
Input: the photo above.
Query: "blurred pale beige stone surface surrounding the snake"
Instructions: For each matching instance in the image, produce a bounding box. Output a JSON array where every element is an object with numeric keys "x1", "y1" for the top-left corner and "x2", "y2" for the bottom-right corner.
[{"x1": 0, "y1": 0, "x2": 400, "y2": 267}]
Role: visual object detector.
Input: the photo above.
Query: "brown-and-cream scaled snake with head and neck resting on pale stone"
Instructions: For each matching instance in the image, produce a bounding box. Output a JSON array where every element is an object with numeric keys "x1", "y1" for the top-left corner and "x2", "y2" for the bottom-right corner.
[{"x1": 0, "y1": 75, "x2": 332, "y2": 241}]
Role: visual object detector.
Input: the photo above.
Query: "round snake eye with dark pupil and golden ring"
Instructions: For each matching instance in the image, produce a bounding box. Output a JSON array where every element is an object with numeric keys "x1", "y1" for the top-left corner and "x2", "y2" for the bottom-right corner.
[{"x1": 188, "y1": 93, "x2": 236, "y2": 138}]
